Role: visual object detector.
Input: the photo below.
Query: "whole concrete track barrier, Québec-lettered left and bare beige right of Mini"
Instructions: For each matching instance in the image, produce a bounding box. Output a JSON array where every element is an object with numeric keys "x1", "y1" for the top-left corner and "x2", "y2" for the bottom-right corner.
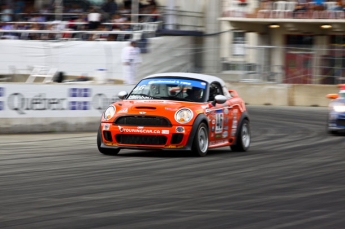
[{"x1": 0, "y1": 83, "x2": 338, "y2": 134}]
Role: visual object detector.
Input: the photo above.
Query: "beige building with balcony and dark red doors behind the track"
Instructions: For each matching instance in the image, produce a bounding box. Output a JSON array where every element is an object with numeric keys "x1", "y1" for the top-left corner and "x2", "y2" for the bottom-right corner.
[{"x1": 219, "y1": 0, "x2": 345, "y2": 84}]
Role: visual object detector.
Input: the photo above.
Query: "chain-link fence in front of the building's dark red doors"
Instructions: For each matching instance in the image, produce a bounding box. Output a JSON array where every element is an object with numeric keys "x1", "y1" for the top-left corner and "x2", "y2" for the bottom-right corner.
[{"x1": 221, "y1": 46, "x2": 345, "y2": 84}]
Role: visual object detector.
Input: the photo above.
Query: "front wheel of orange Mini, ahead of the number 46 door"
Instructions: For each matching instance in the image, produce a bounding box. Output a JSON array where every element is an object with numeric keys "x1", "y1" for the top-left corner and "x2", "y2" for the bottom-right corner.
[{"x1": 192, "y1": 122, "x2": 209, "y2": 157}]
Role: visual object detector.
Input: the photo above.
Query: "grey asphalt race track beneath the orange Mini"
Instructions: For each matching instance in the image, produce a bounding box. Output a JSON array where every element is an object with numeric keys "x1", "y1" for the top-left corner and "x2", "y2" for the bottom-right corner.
[{"x1": 0, "y1": 106, "x2": 345, "y2": 229}]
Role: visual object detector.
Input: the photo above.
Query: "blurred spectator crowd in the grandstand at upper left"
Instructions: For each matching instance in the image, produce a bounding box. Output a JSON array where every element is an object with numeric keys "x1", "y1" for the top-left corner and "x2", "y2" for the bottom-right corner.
[{"x1": 0, "y1": 0, "x2": 160, "y2": 40}]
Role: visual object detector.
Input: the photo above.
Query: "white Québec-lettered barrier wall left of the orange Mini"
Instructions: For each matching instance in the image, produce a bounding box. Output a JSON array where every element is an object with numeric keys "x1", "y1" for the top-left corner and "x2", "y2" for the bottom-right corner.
[{"x1": 0, "y1": 83, "x2": 134, "y2": 134}]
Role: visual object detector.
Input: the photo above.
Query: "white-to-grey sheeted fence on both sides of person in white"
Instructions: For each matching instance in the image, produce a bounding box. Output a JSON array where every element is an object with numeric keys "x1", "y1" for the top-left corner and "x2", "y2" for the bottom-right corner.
[{"x1": 0, "y1": 37, "x2": 193, "y2": 82}]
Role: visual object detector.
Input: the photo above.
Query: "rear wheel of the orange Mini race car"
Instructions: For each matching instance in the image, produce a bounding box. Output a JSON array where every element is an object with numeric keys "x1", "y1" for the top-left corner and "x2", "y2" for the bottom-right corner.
[{"x1": 230, "y1": 119, "x2": 251, "y2": 152}]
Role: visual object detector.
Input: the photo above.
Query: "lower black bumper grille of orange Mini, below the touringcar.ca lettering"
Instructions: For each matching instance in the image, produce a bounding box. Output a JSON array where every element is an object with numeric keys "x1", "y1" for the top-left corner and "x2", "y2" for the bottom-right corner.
[{"x1": 116, "y1": 134, "x2": 167, "y2": 145}]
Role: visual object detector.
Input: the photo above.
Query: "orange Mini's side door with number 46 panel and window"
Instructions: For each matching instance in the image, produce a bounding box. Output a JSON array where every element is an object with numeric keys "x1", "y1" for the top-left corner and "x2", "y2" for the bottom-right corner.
[{"x1": 207, "y1": 82, "x2": 233, "y2": 146}]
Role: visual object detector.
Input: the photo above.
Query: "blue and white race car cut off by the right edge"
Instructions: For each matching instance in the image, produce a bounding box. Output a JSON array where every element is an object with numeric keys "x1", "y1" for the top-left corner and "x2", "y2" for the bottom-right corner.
[{"x1": 327, "y1": 84, "x2": 345, "y2": 134}]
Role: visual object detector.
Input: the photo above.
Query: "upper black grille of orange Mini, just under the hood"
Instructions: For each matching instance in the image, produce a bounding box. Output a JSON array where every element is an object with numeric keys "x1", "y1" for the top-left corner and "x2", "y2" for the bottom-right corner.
[{"x1": 114, "y1": 116, "x2": 172, "y2": 127}]
